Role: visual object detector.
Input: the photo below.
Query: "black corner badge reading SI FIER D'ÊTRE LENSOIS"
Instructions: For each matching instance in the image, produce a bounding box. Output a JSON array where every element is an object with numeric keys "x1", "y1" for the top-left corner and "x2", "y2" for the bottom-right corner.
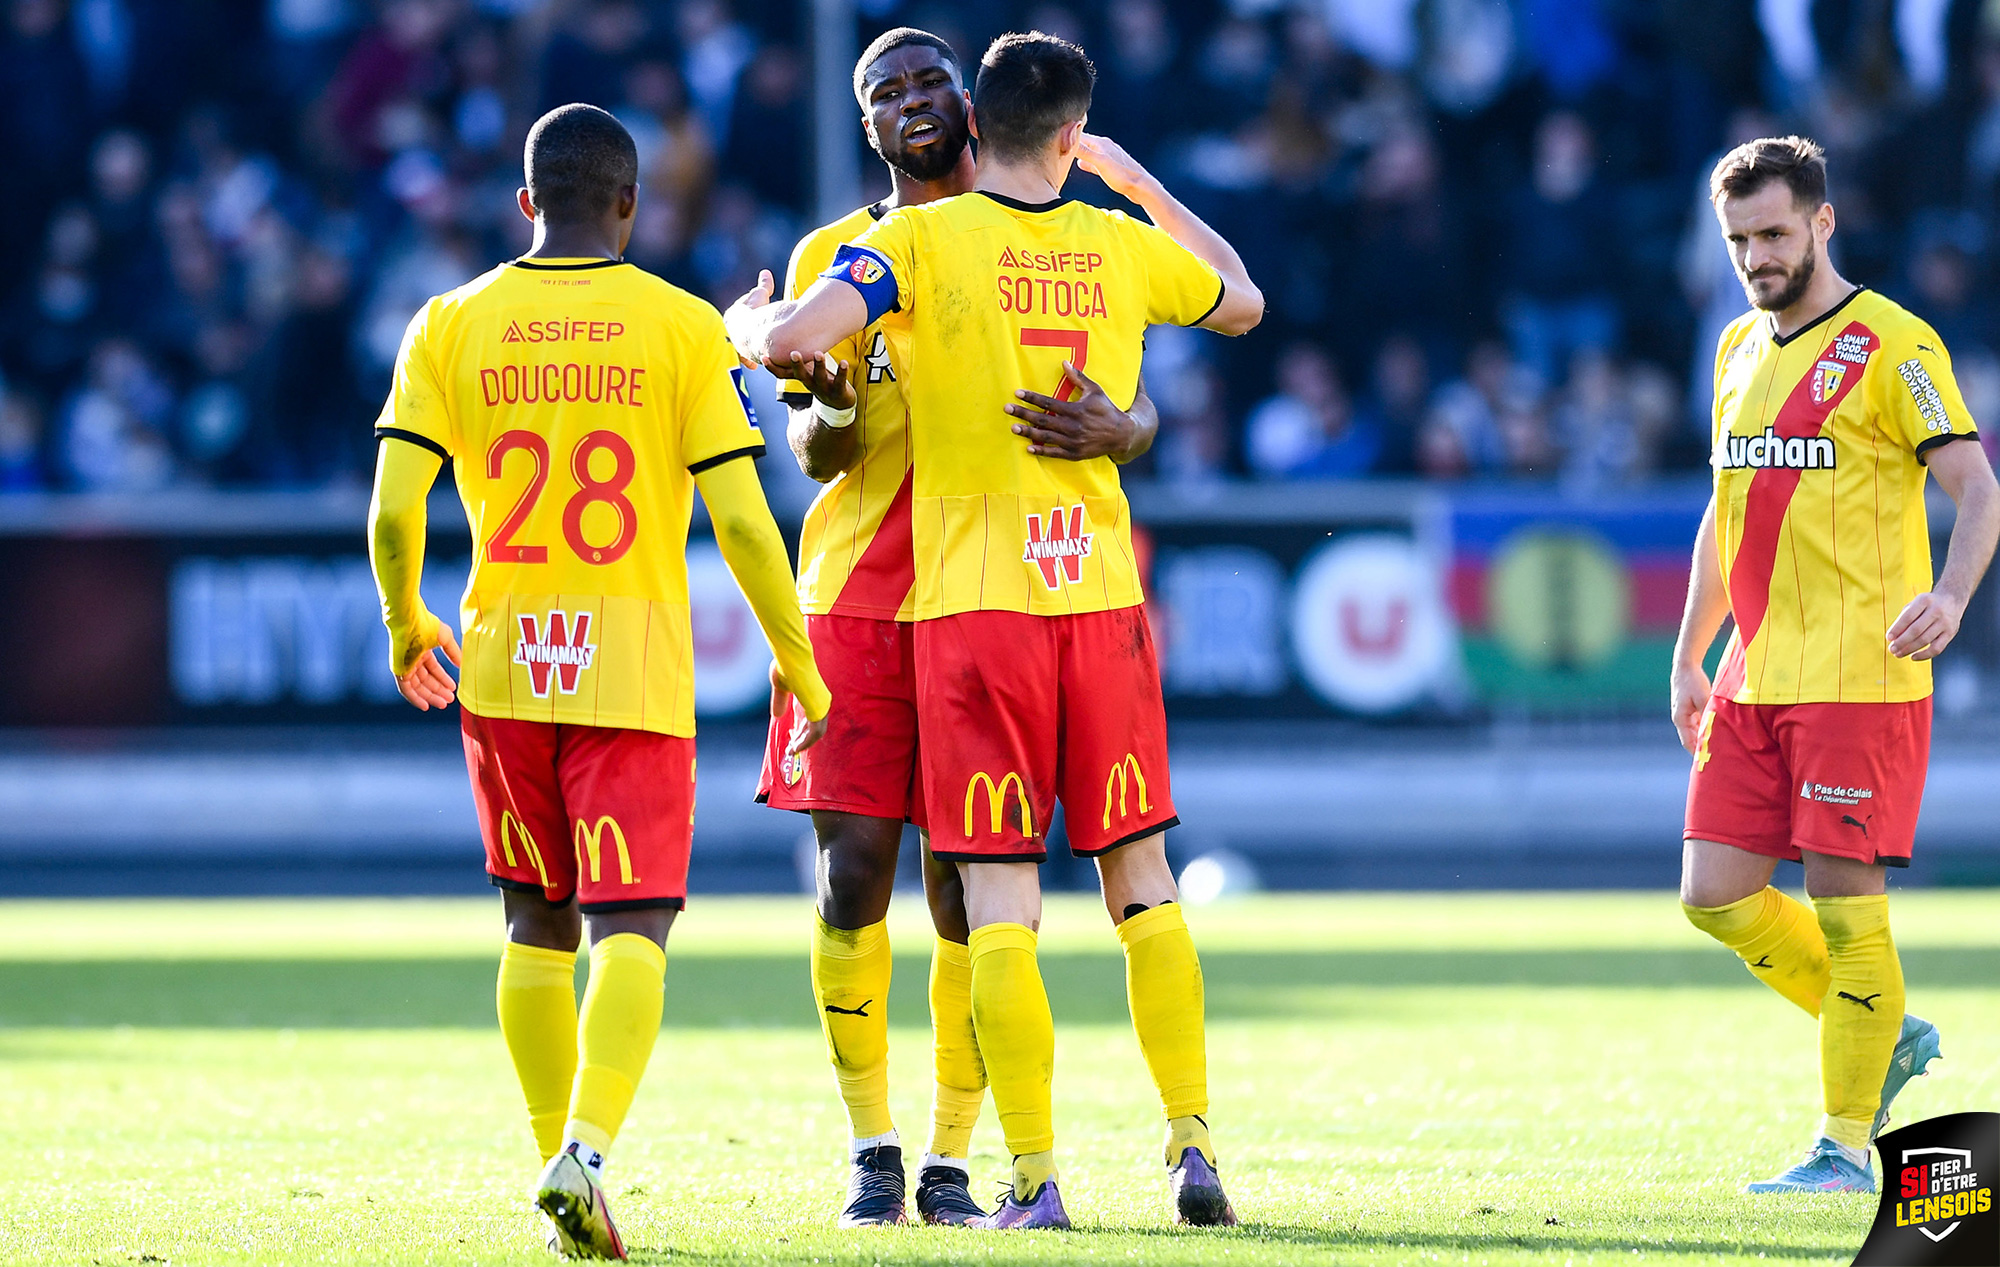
[{"x1": 1854, "y1": 1113, "x2": 2000, "y2": 1267}]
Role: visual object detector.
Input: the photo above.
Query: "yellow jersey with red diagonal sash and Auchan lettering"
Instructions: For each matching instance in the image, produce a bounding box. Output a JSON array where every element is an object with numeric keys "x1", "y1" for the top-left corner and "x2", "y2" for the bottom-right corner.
[{"x1": 1710, "y1": 290, "x2": 1974, "y2": 703}]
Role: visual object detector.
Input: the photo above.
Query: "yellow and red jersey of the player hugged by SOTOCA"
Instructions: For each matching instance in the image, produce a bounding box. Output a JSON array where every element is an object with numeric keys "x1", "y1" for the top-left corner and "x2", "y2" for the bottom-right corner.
[{"x1": 778, "y1": 204, "x2": 916, "y2": 620}]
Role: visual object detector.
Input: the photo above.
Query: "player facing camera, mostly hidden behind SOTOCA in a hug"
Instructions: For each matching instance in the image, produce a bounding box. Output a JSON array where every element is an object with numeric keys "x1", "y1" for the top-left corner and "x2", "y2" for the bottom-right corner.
[{"x1": 758, "y1": 26, "x2": 1158, "y2": 1227}]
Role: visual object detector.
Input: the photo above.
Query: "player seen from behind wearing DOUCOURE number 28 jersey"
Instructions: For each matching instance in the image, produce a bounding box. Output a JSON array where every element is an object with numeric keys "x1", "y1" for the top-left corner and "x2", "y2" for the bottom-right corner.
[{"x1": 368, "y1": 106, "x2": 830, "y2": 1259}]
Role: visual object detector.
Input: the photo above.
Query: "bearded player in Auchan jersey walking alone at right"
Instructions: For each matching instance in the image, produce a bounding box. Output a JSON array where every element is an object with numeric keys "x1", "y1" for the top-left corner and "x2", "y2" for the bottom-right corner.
[{"x1": 1672, "y1": 136, "x2": 2000, "y2": 1193}]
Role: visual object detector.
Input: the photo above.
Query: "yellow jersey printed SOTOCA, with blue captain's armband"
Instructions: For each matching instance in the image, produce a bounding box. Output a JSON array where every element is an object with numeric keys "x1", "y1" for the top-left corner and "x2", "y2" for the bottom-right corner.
[{"x1": 824, "y1": 192, "x2": 1222, "y2": 620}]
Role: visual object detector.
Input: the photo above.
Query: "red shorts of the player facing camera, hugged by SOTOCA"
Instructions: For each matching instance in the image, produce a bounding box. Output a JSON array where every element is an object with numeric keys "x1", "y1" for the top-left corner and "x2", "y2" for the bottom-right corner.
[{"x1": 756, "y1": 616, "x2": 924, "y2": 827}]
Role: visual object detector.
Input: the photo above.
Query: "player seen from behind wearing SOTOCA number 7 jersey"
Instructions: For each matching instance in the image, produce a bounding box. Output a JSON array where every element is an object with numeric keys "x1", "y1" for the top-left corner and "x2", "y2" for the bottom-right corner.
[{"x1": 728, "y1": 32, "x2": 1264, "y2": 1227}]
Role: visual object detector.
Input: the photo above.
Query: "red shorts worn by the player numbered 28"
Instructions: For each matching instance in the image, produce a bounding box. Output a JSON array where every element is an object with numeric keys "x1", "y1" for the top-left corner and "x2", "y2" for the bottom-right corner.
[{"x1": 458, "y1": 707, "x2": 694, "y2": 911}]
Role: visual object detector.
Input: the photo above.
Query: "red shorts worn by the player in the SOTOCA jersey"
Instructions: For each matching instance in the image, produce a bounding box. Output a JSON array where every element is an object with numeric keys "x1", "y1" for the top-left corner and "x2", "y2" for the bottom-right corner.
[{"x1": 916, "y1": 608, "x2": 1180, "y2": 861}]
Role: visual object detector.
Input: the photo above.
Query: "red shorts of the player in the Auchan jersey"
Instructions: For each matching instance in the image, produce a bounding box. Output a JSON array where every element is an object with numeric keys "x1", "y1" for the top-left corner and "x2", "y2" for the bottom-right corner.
[{"x1": 1682, "y1": 699, "x2": 1930, "y2": 867}]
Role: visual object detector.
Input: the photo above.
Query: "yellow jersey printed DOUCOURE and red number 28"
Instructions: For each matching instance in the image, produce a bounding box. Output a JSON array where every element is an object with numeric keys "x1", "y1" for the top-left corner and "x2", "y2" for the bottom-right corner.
[{"x1": 376, "y1": 260, "x2": 764, "y2": 735}]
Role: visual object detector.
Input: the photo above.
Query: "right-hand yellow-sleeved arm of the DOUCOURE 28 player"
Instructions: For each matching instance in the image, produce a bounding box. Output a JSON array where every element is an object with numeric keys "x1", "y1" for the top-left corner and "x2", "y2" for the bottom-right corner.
[{"x1": 694, "y1": 460, "x2": 832, "y2": 751}]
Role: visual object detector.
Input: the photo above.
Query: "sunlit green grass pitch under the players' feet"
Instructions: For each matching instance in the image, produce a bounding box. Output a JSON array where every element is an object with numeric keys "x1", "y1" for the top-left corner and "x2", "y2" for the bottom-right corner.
[{"x1": 0, "y1": 891, "x2": 2000, "y2": 1267}]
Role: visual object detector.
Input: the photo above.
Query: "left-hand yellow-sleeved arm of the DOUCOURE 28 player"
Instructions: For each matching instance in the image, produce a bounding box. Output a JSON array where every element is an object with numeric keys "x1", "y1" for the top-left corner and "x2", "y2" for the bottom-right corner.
[{"x1": 368, "y1": 436, "x2": 458, "y2": 711}]
